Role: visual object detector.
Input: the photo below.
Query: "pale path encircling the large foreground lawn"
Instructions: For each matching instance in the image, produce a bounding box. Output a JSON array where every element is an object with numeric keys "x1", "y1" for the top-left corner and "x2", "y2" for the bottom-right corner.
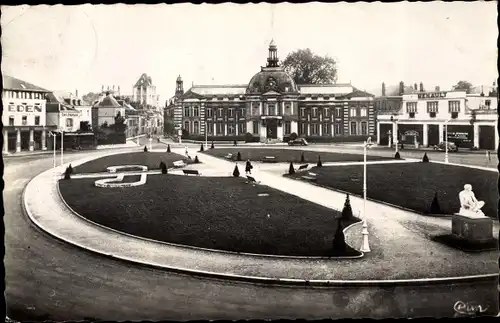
[{"x1": 24, "y1": 149, "x2": 498, "y2": 282}]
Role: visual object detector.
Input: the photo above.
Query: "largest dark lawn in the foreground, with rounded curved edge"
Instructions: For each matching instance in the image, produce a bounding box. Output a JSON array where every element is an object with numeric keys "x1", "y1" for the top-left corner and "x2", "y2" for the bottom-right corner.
[{"x1": 59, "y1": 174, "x2": 359, "y2": 256}]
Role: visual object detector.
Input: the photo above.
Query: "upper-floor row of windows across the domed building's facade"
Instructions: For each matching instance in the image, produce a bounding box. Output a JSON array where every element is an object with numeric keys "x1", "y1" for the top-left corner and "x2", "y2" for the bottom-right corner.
[{"x1": 184, "y1": 105, "x2": 368, "y2": 118}]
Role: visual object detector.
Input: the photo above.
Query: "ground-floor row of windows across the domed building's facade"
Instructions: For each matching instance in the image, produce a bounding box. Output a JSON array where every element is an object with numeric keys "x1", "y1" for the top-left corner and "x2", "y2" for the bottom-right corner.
[{"x1": 184, "y1": 121, "x2": 368, "y2": 136}]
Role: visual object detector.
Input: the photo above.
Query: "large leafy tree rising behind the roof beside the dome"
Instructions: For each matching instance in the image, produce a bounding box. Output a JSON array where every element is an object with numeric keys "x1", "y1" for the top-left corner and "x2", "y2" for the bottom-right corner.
[{"x1": 282, "y1": 48, "x2": 337, "y2": 84}]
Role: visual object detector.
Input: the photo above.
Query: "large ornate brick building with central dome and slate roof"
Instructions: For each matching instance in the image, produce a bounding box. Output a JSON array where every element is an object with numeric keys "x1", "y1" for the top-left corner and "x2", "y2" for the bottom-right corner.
[{"x1": 164, "y1": 42, "x2": 375, "y2": 142}]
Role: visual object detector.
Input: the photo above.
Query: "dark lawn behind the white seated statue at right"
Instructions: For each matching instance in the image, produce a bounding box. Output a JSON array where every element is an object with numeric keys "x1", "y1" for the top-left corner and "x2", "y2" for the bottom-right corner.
[{"x1": 285, "y1": 163, "x2": 498, "y2": 218}]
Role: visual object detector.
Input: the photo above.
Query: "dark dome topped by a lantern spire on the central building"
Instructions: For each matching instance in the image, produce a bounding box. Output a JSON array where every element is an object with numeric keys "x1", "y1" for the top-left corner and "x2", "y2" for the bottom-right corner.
[{"x1": 246, "y1": 40, "x2": 298, "y2": 94}]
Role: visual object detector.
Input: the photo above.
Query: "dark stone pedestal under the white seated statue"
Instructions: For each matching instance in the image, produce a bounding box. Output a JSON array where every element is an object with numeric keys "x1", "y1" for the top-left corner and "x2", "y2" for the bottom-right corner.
[{"x1": 451, "y1": 213, "x2": 493, "y2": 243}]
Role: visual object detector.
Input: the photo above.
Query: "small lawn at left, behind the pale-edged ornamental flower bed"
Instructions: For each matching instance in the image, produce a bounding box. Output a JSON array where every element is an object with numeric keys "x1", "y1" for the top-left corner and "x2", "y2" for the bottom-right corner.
[{"x1": 73, "y1": 151, "x2": 194, "y2": 174}]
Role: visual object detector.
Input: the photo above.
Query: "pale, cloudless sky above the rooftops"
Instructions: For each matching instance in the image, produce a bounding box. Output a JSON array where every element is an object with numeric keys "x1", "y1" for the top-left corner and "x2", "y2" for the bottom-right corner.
[{"x1": 1, "y1": 1, "x2": 498, "y2": 102}]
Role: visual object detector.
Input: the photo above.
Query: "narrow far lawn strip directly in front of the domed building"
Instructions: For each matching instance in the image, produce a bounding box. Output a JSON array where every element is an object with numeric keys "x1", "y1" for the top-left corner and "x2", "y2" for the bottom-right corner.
[{"x1": 204, "y1": 148, "x2": 393, "y2": 163}]
